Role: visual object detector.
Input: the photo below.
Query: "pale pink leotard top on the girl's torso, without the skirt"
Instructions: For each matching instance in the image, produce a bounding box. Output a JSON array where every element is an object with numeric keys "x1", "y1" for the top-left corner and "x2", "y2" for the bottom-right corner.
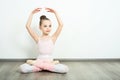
[{"x1": 38, "y1": 37, "x2": 54, "y2": 59}]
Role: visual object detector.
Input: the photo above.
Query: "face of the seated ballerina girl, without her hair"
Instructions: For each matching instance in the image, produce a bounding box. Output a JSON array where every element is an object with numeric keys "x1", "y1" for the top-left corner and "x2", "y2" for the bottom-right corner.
[{"x1": 40, "y1": 20, "x2": 52, "y2": 35}]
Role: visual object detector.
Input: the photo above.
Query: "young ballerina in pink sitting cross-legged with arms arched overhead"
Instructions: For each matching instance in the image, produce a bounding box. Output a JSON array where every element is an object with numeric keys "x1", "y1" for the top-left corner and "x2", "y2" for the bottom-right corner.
[{"x1": 20, "y1": 8, "x2": 69, "y2": 73}]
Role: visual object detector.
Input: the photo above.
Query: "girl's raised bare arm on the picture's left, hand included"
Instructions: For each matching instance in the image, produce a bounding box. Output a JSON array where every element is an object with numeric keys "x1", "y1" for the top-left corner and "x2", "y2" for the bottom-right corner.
[{"x1": 26, "y1": 8, "x2": 41, "y2": 43}]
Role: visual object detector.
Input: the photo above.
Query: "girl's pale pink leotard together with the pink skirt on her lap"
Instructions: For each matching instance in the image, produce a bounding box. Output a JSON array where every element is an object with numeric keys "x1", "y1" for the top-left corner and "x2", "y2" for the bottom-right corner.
[{"x1": 34, "y1": 37, "x2": 54, "y2": 70}]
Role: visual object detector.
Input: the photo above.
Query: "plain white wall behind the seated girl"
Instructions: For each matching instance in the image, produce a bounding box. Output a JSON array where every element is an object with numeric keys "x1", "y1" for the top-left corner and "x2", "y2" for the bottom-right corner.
[{"x1": 0, "y1": 0, "x2": 120, "y2": 59}]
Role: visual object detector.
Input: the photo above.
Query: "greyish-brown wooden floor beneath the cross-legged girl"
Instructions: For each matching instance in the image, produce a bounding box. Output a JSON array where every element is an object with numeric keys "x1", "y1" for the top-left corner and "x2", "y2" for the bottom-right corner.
[{"x1": 0, "y1": 61, "x2": 120, "y2": 80}]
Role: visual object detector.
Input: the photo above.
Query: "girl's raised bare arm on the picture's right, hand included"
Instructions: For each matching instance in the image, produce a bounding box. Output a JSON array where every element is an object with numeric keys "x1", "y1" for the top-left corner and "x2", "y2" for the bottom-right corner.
[{"x1": 46, "y1": 8, "x2": 63, "y2": 43}]
